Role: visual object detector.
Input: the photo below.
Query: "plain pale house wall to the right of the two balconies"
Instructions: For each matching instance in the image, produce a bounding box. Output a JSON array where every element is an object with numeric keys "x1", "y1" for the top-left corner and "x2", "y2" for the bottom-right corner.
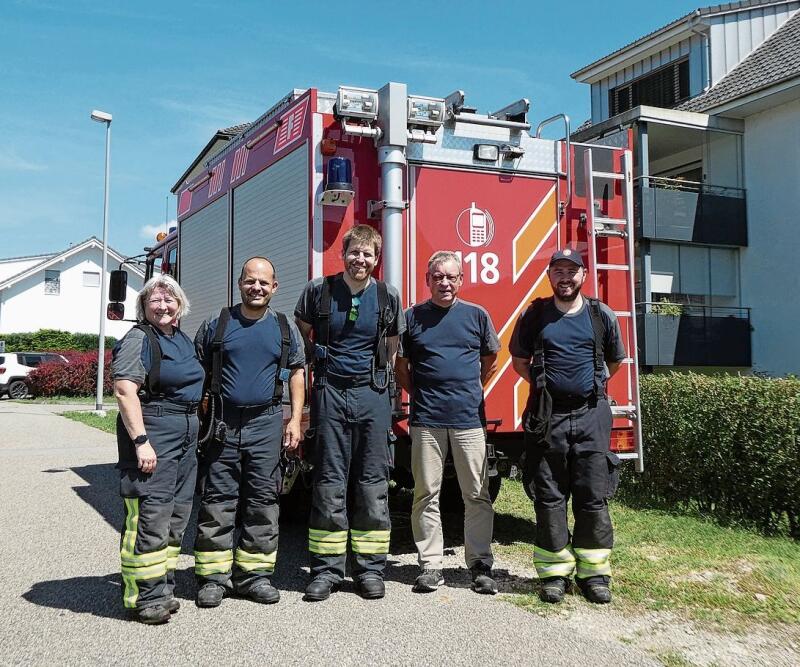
[{"x1": 741, "y1": 95, "x2": 800, "y2": 375}]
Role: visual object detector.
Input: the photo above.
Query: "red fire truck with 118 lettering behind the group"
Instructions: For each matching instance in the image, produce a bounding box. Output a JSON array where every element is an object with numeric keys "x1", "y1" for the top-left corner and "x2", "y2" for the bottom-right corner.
[{"x1": 131, "y1": 83, "x2": 643, "y2": 496}]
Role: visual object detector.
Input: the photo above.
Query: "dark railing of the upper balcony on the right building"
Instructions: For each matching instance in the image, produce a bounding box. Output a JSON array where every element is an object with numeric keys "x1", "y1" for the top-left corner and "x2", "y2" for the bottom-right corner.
[{"x1": 636, "y1": 176, "x2": 747, "y2": 246}]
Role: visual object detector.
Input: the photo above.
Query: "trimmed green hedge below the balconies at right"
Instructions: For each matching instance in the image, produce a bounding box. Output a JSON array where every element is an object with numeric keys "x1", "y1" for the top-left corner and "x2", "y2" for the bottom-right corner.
[{"x1": 620, "y1": 373, "x2": 800, "y2": 538}]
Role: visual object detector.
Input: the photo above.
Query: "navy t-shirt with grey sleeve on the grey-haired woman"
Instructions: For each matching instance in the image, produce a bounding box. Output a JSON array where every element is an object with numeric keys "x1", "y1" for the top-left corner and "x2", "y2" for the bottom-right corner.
[{"x1": 111, "y1": 327, "x2": 205, "y2": 402}]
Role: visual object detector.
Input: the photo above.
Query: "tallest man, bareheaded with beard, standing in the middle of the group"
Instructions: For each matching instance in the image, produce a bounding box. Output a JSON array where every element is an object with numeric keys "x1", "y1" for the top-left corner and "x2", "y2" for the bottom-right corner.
[{"x1": 295, "y1": 225, "x2": 405, "y2": 601}]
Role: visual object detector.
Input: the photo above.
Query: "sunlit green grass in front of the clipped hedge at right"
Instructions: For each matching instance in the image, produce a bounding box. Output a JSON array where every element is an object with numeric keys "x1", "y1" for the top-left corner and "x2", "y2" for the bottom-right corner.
[{"x1": 495, "y1": 480, "x2": 800, "y2": 629}]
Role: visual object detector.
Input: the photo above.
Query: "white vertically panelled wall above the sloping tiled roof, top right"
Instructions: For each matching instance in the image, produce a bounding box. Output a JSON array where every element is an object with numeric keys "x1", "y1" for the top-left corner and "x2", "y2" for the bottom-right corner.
[{"x1": 708, "y1": 2, "x2": 800, "y2": 86}]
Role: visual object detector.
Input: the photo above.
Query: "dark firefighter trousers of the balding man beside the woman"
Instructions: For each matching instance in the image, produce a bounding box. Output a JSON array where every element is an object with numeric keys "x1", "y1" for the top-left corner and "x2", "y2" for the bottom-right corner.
[{"x1": 194, "y1": 405, "x2": 283, "y2": 593}]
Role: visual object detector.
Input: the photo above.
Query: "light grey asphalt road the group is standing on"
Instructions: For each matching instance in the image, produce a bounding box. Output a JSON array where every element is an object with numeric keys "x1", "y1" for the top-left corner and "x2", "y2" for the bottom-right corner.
[{"x1": 0, "y1": 400, "x2": 659, "y2": 667}]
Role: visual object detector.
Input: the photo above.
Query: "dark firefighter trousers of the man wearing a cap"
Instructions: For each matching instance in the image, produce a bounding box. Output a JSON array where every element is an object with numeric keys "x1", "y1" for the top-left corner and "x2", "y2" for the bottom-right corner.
[{"x1": 525, "y1": 398, "x2": 619, "y2": 585}]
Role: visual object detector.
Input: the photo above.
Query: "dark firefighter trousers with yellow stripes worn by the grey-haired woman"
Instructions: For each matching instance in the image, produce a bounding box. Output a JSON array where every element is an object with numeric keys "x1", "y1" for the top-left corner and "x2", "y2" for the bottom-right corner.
[{"x1": 117, "y1": 401, "x2": 199, "y2": 609}]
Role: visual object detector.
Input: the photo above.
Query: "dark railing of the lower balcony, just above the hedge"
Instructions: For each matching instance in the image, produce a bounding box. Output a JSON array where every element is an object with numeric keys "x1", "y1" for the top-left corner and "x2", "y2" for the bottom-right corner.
[{"x1": 636, "y1": 302, "x2": 751, "y2": 366}]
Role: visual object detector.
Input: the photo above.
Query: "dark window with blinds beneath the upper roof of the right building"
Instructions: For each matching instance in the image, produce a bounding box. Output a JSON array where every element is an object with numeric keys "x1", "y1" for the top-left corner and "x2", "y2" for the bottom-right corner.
[{"x1": 608, "y1": 58, "x2": 689, "y2": 116}]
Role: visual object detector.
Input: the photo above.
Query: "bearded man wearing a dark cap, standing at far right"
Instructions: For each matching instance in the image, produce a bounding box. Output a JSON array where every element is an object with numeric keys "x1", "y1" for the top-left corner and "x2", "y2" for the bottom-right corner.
[{"x1": 511, "y1": 248, "x2": 625, "y2": 604}]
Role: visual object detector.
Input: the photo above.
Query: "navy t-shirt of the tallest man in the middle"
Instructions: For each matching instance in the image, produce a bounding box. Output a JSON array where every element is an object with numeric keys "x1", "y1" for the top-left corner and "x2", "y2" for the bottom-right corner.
[{"x1": 294, "y1": 277, "x2": 406, "y2": 376}]
